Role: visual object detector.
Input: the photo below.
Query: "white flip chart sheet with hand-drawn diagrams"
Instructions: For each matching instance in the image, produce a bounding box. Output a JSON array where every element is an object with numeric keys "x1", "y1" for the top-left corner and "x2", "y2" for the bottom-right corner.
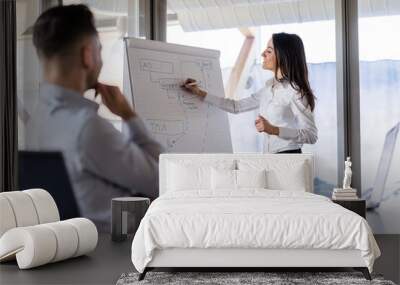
[{"x1": 127, "y1": 39, "x2": 232, "y2": 153}]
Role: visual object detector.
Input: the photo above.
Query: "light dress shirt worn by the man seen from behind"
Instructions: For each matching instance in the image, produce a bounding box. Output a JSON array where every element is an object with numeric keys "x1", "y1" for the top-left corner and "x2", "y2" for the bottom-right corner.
[{"x1": 28, "y1": 83, "x2": 163, "y2": 231}]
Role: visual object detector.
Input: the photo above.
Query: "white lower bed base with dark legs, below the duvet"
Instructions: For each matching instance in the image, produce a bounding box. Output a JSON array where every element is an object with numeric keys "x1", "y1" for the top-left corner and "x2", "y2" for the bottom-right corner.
[{"x1": 139, "y1": 248, "x2": 371, "y2": 280}]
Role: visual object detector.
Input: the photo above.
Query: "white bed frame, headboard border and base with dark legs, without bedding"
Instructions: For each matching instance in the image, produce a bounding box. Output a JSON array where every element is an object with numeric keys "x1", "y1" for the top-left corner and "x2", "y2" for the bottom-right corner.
[{"x1": 139, "y1": 153, "x2": 371, "y2": 280}]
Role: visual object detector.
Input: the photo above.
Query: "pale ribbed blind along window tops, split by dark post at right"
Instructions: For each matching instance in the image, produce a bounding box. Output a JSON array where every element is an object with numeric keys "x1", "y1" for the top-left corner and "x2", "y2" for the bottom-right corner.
[{"x1": 168, "y1": 0, "x2": 400, "y2": 32}]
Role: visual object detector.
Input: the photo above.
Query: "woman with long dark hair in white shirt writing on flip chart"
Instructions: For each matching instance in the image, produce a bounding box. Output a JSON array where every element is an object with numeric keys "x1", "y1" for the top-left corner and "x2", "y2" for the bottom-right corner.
[{"x1": 182, "y1": 33, "x2": 318, "y2": 153}]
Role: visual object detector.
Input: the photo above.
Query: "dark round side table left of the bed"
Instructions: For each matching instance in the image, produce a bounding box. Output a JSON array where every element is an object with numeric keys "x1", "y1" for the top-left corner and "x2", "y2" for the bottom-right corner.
[{"x1": 111, "y1": 197, "x2": 150, "y2": 241}]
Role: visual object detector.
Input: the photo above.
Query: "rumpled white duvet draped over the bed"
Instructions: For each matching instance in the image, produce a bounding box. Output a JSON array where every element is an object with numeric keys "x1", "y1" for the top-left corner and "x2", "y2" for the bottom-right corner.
[{"x1": 132, "y1": 189, "x2": 380, "y2": 272}]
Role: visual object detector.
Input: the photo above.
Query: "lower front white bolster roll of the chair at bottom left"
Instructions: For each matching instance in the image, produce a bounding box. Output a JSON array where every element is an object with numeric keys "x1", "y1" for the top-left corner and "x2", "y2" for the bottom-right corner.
[{"x1": 0, "y1": 218, "x2": 98, "y2": 269}]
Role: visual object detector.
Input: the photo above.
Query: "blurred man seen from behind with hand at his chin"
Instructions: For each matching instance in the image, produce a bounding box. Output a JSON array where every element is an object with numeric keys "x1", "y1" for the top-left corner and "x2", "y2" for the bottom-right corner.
[{"x1": 28, "y1": 5, "x2": 162, "y2": 231}]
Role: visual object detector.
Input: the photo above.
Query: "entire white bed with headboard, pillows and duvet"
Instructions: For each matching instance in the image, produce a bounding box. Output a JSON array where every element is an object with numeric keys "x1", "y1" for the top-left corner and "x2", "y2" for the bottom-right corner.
[{"x1": 132, "y1": 154, "x2": 380, "y2": 279}]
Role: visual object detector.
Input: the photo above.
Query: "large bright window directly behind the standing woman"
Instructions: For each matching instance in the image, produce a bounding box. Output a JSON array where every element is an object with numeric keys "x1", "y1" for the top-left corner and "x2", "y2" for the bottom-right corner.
[{"x1": 167, "y1": 1, "x2": 338, "y2": 196}]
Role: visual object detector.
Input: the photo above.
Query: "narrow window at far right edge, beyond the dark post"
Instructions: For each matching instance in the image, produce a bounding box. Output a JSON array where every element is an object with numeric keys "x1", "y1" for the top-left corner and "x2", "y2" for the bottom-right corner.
[{"x1": 358, "y1": 3, "x2": 400, "y2": 234}]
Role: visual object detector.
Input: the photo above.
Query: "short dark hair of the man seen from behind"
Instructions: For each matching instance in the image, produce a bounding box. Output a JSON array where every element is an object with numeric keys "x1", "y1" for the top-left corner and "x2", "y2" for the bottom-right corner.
[{"x1": 33, "y1": 4, "x2": 97, "y2": 58}]
